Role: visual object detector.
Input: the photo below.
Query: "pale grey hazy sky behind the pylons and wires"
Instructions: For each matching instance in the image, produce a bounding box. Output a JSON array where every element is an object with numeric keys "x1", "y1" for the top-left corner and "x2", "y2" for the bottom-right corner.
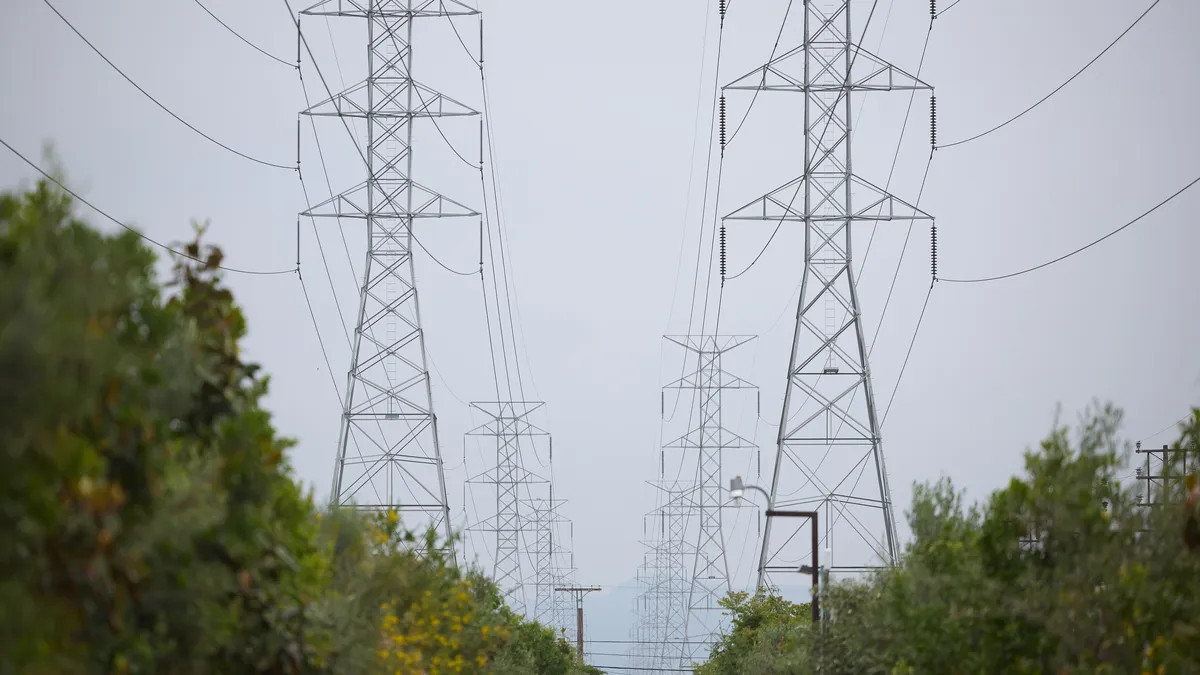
[{"x1": 0, "y1": 0, "x2": 1200, "y2": 653}]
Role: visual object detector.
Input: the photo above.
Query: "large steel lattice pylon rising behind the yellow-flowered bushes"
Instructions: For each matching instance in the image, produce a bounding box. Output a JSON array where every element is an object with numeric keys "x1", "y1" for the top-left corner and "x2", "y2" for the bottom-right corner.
[{"x1": 302, "y1": 0, "x2": 478, "y2": 547}]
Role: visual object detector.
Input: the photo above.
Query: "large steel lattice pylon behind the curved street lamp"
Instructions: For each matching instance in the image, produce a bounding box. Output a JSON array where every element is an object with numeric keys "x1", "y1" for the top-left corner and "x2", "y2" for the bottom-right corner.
[{"x1": 724, "y1": 0, "x2": 930, "y2": 586}]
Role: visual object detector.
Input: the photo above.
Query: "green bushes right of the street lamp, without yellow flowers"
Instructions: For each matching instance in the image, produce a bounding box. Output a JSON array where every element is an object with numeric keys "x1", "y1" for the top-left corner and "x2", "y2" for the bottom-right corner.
[{"x1": 700, "y1": 407, "x2": 1200, "y2": 675}]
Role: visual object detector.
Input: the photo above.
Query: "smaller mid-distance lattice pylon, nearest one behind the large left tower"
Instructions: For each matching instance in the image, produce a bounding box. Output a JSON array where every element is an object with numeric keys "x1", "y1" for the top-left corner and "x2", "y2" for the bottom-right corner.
[{"x1": 467, "y1": 401, "x2": 550, "y2": 614}]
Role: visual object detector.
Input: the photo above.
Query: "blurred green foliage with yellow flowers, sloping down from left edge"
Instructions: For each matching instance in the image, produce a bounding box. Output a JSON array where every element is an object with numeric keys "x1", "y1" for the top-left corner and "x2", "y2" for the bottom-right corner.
[{"x1": 0, "y1": 174, "x2": 592, "y2": 675}]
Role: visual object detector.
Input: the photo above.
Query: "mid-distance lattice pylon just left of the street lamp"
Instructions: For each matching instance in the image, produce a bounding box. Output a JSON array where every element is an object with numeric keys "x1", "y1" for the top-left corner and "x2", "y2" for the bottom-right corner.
[{"x1": 664, "y1": 335, "x2": 756, "y2": 665}]
